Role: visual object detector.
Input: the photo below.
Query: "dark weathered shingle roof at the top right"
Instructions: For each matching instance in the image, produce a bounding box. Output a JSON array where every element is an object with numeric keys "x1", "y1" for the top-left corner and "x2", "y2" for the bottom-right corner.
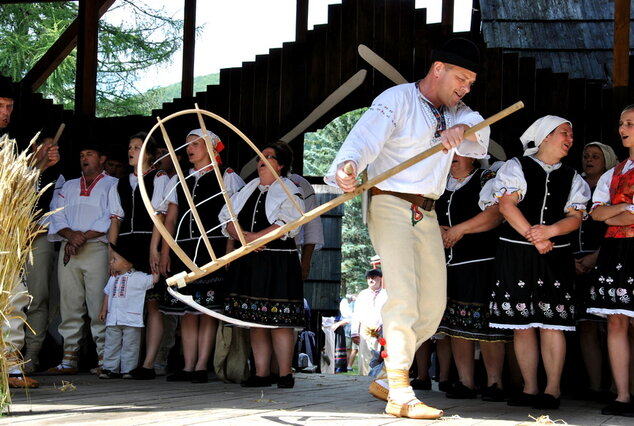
[{"x1": 476, "y1": 0, "x2": 634, "y2": 85}]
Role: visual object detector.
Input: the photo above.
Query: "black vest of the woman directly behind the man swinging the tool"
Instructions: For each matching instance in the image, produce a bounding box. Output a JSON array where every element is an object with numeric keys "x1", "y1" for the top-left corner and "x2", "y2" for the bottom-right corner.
[{"x1": 436, "y1": 169, "x2": 498, "y2": 265}]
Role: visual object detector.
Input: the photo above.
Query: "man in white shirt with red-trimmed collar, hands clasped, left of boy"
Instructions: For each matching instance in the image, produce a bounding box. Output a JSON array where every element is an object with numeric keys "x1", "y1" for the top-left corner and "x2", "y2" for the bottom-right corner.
[{"x1": 47, "y1": 143, "x2": 123, "y2": 374}]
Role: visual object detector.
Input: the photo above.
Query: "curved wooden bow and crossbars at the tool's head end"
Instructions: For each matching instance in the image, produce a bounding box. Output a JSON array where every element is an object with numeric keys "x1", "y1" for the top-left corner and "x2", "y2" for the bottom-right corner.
[{"x1": 137, "y1": 104, "x2": 303, "y2": 287}]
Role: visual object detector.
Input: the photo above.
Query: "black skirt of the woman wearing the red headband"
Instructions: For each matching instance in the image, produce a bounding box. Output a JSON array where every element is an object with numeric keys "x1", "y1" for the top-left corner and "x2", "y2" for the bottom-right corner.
[{"x1": 159, "y1": 238, "x2": 226, "y2": 315}]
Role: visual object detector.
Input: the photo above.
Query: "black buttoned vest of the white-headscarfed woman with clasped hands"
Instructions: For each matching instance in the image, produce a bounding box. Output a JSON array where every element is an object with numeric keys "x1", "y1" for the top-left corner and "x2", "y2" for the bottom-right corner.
[{"x1": 501, "y1": 157, "x2": 577, "y2": 245}]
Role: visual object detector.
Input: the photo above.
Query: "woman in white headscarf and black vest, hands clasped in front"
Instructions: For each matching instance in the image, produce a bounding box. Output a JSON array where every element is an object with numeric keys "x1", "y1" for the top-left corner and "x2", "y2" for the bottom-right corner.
[{"x1": 480, "y1": 115, "x2": 590, "y2": 408}]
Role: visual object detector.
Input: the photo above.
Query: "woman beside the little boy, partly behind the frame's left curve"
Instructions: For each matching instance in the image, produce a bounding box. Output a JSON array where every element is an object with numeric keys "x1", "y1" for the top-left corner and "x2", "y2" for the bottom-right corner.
[{"x1": 113, "y1": 132, "x2": 169, "y2": 379}]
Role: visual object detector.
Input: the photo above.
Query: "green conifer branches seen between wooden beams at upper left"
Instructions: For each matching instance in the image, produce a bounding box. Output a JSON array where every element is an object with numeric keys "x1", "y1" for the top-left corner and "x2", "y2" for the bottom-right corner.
[{"x1": 0, "y1": 0, "x2": 183, "y2": 116}]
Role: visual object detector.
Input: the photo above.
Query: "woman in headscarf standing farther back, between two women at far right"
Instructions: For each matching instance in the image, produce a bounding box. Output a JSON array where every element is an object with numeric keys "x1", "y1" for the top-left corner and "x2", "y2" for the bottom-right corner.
[{"x1": 573, "y1": 142, "x2": 618, "y2": 401}]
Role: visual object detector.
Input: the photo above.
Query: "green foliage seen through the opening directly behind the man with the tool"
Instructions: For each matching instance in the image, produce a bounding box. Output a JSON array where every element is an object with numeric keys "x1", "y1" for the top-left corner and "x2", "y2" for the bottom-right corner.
[{"x1": 304, "y1": 108, "x2": 376, "y2": 295}]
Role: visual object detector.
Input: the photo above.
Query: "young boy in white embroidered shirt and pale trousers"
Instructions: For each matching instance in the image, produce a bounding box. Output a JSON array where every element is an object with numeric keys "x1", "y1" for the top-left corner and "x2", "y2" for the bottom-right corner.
[{"x1": 99, "y1": 243, "x2": 159, "y2": 379}]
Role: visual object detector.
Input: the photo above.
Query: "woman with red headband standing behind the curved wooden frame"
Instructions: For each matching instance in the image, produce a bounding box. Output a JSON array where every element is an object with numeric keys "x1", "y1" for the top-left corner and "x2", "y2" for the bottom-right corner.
[{"x1": 160, "y1": 129, "x2": 244, "y2": 383}]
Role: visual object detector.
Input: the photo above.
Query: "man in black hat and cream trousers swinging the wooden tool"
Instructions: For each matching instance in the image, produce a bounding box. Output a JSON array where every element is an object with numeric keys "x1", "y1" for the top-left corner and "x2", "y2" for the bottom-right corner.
[{"x1": 325, "y1": 38, "x2": 490, "y2": 419}]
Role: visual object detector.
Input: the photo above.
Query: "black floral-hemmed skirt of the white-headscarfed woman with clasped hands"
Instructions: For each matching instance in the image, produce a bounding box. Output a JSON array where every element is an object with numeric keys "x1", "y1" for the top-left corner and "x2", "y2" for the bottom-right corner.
[{"x1": 489, "y1": 240, "x2": 576, "y2": 331}]
